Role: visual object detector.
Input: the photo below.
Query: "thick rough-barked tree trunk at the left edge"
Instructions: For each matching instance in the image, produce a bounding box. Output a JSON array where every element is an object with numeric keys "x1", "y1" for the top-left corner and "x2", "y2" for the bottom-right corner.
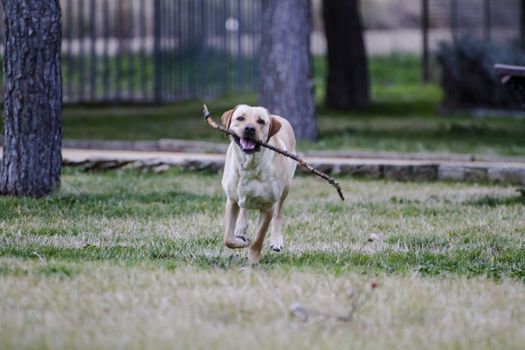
[{"x1": 0, "y1": 0, "x2": 62, "y2": 197}]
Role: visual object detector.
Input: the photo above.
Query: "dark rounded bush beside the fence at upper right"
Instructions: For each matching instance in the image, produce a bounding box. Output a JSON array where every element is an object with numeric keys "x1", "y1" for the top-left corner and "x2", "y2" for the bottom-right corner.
[{"x1": 438, "y1": 37, "x2": 525, "y2": 109}]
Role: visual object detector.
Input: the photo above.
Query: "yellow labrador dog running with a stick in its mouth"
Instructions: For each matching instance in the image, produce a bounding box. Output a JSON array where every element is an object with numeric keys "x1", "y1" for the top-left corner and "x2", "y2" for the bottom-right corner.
[{"x1": 221, "y1": 105, "x2": 296, "y2": 264}]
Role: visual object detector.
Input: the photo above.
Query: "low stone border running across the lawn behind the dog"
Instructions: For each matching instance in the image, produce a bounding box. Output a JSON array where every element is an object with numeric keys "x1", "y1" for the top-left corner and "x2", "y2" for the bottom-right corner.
[{"x1": 60, "y1": 153, "x2": 525, "y2": 185}]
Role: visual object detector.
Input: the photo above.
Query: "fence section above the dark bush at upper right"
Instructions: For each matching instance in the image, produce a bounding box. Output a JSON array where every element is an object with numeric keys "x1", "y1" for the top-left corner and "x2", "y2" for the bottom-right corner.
[{"x1": 421, "y1": 0, "x2": 525, "y2": 80}]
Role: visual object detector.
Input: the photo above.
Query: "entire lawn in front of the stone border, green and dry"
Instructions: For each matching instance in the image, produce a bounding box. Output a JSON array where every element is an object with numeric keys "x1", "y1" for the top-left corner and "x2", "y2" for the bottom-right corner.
[{"x1": 0, "y1": 169, "x2": 525, "y2": 349}]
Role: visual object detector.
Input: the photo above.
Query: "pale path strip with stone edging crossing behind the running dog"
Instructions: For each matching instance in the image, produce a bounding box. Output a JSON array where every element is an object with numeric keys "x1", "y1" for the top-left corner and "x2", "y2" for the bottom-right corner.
[{"x1": 0, "y1": 148, "x2": 525, "y2": 185}]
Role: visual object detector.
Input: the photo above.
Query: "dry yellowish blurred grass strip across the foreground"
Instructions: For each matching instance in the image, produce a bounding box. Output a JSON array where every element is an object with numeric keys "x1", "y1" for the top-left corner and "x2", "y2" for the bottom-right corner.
[{"x1": 0, "y1": 258, "x2": 525, "y2": 349}]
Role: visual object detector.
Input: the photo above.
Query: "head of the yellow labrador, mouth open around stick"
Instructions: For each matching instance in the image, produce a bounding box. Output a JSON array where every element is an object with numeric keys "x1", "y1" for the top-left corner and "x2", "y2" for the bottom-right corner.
[{"x1": 221, "y1": 105, "x2": 281, "y2": 154}]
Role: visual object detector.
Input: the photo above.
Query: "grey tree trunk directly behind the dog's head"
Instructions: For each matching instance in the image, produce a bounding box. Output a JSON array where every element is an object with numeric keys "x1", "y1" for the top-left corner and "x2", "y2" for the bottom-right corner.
[{"x1": 259, "y1": 0, "x2": 317, "y2": 139}]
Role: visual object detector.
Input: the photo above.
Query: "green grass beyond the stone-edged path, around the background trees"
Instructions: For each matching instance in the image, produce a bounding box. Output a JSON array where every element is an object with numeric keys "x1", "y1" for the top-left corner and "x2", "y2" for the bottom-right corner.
[{"x1": 51, "y1": 55, "x2": 525, "y2": 156}]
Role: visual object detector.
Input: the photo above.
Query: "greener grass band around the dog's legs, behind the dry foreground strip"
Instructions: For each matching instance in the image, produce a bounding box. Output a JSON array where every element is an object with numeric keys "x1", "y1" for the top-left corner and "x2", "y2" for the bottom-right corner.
[{"x1": 0, "y1": 171, "x2": 525, "y2": 280}]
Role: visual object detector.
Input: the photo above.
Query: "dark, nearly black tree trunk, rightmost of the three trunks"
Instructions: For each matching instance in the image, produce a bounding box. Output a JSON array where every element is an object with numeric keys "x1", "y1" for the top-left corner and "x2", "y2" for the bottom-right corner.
[{"x1": 323, "y1": 0, "x2": 370, "y2": 110}]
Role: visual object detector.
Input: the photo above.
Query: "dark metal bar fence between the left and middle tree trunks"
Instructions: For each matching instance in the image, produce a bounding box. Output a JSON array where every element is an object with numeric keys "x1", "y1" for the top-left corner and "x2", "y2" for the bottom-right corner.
[{"x1": 1, "y1": 0, "x2": 261, "y2": 103}]
